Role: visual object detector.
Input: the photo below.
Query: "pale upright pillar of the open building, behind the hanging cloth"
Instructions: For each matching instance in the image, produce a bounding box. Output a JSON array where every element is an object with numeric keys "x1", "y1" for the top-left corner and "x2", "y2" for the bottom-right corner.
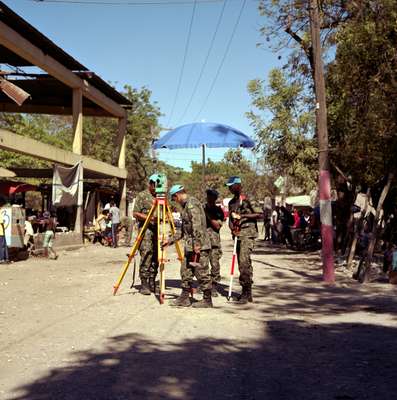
[{"x1": 73, "y1": 88, "x2": 84, "y2": 235}]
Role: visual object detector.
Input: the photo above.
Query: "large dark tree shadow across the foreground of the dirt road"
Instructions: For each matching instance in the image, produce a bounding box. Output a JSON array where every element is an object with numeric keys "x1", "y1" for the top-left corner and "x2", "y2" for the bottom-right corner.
[{"x1": 7, "y1": 319, "x2": 397, "y2": 400}]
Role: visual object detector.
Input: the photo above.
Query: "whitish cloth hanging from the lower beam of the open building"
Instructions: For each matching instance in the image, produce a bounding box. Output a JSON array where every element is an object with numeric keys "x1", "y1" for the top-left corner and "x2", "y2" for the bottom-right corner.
[{"x1": 52, "y1": 162, "x2": 83, "y2": 207}]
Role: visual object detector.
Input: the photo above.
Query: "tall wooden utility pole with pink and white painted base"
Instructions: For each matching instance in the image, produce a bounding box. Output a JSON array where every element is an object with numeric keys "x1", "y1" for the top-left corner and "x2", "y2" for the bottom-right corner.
[{"x1": 309, "y1": 0, "x2": 335, "y2": 283}]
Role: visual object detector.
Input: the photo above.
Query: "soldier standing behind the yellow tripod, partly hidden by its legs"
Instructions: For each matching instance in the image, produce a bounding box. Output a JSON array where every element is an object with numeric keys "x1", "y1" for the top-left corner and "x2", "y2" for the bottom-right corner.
[{"x1": 132, "y1": 174, "x2": 158, "y2": 295}]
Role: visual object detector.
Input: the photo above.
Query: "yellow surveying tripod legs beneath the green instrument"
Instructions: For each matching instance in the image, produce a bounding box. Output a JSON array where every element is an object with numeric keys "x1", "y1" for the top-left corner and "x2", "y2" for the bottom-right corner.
[{"x1": 113, "y1": 194, "x2": 183, "y2": 304}]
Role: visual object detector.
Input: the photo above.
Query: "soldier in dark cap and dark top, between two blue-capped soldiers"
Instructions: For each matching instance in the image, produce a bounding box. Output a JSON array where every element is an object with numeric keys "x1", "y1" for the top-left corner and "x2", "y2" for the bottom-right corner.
[{"x1": 204, "y1": 189, "x2": 225, "y2": 297}]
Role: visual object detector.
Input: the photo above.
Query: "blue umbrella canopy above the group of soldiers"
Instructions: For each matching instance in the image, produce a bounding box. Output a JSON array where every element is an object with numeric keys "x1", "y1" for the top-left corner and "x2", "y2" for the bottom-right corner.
[{"x1": 153, "y1": 122, "x2": 255, "y2": 149}]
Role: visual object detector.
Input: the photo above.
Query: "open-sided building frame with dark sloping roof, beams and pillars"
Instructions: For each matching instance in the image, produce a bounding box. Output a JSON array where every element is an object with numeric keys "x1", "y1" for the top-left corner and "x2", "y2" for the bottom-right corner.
[{"x1": 0, "y1": 1, "x2": 132, "y2": 228}]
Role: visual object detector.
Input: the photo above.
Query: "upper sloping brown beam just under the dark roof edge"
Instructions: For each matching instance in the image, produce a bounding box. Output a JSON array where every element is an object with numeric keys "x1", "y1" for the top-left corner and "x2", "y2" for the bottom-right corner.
[{"x1": 0, "y1": 21, "x2": 126, "y2": 118}]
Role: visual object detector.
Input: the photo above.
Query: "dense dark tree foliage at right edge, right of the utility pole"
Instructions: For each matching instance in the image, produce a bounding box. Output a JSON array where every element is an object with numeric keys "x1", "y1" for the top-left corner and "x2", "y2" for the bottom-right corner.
[{"x1": 327, "y1": 0, "x2": 397, "y2": 185}]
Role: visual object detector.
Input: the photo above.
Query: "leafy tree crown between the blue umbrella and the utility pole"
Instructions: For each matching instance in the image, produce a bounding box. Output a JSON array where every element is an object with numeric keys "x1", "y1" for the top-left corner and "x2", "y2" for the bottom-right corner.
[{"x1": 247, "y1": 69, "x2": 317, "y2": 190}]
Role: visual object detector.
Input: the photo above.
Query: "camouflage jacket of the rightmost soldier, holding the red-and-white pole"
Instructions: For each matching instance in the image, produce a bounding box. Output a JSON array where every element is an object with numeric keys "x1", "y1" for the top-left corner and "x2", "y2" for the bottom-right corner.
[{"x1": 229, "y1": 194, "x2": 261, "y2": 238}]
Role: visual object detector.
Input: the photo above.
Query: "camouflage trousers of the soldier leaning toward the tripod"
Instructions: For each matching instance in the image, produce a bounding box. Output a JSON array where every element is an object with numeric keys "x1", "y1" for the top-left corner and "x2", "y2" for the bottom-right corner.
[{"x1": 181, "y1": 250, "x2": 212, "y2": 291}]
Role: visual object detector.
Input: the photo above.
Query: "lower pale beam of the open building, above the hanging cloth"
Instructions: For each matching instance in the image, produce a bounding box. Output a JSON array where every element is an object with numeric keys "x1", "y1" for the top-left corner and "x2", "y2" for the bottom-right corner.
[{"x1": 0, "y1": 129, "x2": 127, "y2": 179}]
